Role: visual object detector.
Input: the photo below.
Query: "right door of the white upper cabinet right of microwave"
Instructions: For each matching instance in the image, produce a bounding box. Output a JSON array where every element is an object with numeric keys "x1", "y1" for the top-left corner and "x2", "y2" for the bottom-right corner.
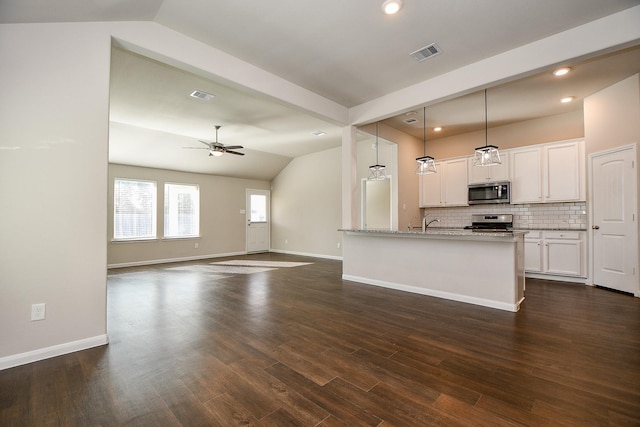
[{"x1": 543, "y1": 142, "x2": 584, "y2": 202}]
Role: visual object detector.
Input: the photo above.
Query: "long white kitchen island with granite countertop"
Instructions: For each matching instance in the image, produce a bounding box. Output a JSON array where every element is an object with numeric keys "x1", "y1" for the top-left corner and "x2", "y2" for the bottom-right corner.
[{"x1": 340, "y1": 228, "x2": 526, "y2": 312}]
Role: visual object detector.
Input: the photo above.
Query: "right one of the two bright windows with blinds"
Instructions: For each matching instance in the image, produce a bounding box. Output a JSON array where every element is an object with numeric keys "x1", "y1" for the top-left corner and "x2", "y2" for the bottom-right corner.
[{"x1": 164, "y1": 184, "x2": 200, "y2": 238}]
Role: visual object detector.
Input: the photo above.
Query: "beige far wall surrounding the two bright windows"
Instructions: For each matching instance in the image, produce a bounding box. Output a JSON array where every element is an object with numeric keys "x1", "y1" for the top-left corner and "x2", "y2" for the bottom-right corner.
[{"x1": 107, "y1": 164, "x2": 269, "y2": 266}]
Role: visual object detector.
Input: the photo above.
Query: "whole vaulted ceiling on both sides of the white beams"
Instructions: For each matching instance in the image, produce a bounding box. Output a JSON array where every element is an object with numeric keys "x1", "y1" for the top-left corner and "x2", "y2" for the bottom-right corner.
[{"x1": 0, "y1": 0, "x2": 640, "y2": 179}]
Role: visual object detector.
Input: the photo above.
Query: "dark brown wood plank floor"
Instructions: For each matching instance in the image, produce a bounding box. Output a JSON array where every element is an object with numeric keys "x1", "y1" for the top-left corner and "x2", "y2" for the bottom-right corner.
[{"x1": 0, "y1": 254, "x2": 640, "y2": 427}]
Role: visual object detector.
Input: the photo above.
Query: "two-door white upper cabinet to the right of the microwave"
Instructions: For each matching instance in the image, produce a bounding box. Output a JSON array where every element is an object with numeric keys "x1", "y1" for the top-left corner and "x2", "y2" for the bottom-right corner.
[{"x1": 510, "y1": 140, "x2": 585, "y2": 203}]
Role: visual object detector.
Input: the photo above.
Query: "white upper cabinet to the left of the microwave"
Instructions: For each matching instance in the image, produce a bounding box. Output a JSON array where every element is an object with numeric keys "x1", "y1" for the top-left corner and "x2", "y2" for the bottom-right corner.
[{"x1": 420, "y1": 157, "x2": 468, "y2": 208}]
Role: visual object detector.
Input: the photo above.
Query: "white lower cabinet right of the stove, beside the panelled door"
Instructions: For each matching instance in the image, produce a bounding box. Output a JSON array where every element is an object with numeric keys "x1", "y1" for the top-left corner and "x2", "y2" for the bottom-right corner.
[{"x1": 524, "y1": 230, "x2": 587, "y2": 278}]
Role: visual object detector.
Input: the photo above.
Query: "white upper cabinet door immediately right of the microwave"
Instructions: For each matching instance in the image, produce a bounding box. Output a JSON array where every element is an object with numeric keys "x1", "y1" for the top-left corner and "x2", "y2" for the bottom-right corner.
[{"x1": 510, "y1": 147, "x2": 542, "y2": 203}]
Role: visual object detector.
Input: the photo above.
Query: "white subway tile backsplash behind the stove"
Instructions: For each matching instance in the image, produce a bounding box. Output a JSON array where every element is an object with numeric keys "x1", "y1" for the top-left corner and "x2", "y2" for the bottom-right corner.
[{"x1": 422, "y1": 202, "x2": 587, "y2": 230}]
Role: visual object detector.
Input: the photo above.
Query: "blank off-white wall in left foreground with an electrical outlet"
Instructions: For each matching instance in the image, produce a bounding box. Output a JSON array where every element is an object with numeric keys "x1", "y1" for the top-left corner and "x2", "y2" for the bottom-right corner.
[{"x1": 0, "y1": 24, "x2": 111, "y2": 369}]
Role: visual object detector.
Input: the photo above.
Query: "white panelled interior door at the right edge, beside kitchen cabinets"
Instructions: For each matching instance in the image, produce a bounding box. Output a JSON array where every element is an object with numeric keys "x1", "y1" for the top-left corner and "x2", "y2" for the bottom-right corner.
[{"x1": 590, "y1": 146, "x2": 640, "y2": 296}]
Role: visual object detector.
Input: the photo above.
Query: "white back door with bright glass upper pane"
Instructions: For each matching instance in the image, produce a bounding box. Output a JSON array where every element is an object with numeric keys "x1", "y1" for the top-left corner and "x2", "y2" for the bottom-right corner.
[{"x1": 246, "y1": 189, "x2": 270, "y2": 252}]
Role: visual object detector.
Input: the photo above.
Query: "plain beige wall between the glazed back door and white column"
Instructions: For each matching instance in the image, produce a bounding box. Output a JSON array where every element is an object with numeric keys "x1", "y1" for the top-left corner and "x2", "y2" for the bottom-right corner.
[{"x1": 271, "y1": 148, "x2": 342, "y2": 258}]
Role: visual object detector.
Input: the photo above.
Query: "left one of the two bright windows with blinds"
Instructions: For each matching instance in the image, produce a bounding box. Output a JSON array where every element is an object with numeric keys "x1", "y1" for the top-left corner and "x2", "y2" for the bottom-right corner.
[{"x1": 113, "y1": 178, "x2": 156, "y2": 240}]
